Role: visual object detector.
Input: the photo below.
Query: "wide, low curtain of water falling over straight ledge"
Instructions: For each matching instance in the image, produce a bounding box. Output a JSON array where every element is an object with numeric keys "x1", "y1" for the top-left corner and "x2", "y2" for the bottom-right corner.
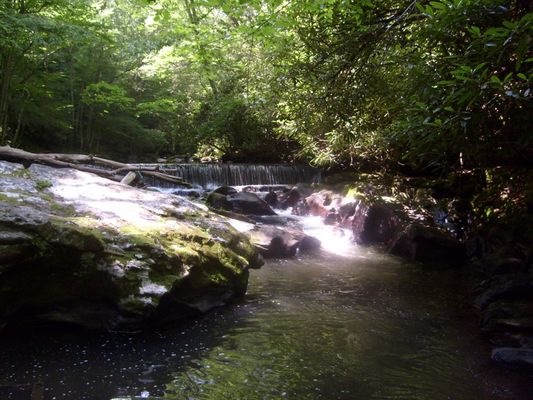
[{"x1": 138, "y1": 164, "x2": 321, "y2": 188}]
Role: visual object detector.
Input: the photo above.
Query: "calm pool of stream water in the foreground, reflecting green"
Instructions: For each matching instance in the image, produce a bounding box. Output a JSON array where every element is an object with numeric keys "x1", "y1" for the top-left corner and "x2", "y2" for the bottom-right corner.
[{"x1": 0, "y1": 248, "x2": 533, "y2": 400}]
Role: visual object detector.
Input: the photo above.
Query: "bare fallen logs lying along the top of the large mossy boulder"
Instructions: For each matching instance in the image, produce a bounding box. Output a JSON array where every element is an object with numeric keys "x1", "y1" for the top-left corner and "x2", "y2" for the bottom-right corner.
[{"x1": 0, "y1": 146, "x2": 191, "y2": 187}]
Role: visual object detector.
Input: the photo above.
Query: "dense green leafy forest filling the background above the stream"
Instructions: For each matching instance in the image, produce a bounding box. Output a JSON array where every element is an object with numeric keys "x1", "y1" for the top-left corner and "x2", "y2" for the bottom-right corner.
[{"x1": 0, "y1": 0, "x2": 533, "y2": 173}]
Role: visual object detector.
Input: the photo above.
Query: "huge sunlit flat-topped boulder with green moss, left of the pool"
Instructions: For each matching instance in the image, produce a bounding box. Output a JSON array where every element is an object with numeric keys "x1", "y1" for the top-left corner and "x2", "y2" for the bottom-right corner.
[{"x1": 0, "y1": 162, "x2": 260, "y2": 331}]
